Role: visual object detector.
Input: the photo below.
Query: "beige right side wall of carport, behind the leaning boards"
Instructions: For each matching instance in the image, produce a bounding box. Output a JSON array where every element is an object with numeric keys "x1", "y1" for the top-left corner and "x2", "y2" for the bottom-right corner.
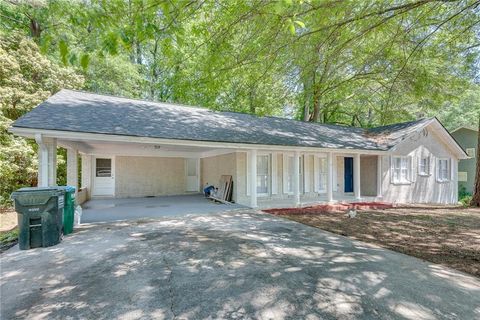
[{"x1": 200, "y1": 153, "x2": 237, "y2": 201}]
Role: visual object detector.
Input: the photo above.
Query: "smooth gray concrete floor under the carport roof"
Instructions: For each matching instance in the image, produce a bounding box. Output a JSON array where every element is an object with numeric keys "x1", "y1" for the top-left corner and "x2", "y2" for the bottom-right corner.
[{"x1": 81, "y1": 194, "x2": 245, "y2": 223}]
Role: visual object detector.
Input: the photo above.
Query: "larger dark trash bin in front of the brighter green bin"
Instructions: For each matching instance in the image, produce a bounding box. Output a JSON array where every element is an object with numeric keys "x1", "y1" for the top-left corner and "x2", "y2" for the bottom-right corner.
[{"x1": 12, "y1": 187, "x2": 65, "y2": 250}]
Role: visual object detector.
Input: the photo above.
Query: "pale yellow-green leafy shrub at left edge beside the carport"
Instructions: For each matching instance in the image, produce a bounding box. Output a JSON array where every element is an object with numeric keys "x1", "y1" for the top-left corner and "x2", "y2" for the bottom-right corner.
[{"x1": 0, "y1": 34, "x2": 83, "y2": 206}]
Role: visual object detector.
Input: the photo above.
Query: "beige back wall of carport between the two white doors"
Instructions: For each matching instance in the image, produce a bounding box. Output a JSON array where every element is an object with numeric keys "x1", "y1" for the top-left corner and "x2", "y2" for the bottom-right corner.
[{"x1": 115, "y1": 156, "x2": 186, "y2": 198}]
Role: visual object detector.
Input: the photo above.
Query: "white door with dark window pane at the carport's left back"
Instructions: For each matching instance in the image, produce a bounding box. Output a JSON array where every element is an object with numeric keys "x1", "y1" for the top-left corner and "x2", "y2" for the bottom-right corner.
[{"x1": 92, "y1": 157, "x2": 115, "y2": 196}]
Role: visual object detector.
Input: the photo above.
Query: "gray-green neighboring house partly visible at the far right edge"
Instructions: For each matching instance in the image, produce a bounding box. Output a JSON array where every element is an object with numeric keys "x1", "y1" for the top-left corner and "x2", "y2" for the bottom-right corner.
[{"x1": 452, "y1": 127, "x2": 478, "y2": 194}]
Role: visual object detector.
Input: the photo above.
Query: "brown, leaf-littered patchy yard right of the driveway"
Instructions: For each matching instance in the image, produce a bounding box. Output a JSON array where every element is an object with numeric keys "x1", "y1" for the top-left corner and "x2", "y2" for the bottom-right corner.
[{"x1": 266, "y1": 206, "x2": 480, "y2": 277}]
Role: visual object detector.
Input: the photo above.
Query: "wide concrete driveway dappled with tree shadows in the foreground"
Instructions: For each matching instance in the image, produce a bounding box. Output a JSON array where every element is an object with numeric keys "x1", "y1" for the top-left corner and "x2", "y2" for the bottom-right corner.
[{"x1": 0, "y1": 210, "x2": 480, "y2": 320}]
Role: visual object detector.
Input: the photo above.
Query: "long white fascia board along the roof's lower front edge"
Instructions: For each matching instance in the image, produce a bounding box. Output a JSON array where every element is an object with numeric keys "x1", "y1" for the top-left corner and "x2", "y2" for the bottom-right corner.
[{"x1": 8, "y1": 127, "x2": 388, "y2": 155}]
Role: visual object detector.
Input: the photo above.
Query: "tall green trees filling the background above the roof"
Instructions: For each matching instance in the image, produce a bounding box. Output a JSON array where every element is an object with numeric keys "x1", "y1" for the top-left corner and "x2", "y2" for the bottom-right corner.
[{"x1": 0, "y1": 0, "x2": 480, "y2": 206}]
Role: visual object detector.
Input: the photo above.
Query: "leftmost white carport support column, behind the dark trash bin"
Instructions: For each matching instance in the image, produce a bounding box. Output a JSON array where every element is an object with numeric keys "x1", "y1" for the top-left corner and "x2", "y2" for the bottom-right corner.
[{"x1": 35, "y1": 134, "x2": 57, "y2": 187}]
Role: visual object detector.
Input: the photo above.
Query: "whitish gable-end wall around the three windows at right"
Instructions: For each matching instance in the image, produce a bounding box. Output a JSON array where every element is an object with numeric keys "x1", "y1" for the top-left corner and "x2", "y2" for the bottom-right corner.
[{"x1": 382, "y1": 126, "x2": 457, "y2": 204}]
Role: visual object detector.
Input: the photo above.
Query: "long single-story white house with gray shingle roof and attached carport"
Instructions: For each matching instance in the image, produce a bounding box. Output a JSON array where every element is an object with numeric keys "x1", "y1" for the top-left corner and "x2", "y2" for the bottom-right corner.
[{"x1": 10, "y1": 90, "x2": 467, "y2": 207}]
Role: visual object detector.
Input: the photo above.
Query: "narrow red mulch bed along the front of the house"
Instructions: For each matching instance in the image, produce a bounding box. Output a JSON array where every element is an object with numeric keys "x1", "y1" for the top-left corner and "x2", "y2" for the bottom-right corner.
[{"x1": 263, "y1": 202, "x2": 393, "y2": 215}]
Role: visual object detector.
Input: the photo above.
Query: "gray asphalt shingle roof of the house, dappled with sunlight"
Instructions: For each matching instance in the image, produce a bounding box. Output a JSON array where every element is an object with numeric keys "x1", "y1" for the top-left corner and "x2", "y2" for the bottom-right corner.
[{"x1": 13, "y1": 90, "x2": 431, "y2": 150}]
